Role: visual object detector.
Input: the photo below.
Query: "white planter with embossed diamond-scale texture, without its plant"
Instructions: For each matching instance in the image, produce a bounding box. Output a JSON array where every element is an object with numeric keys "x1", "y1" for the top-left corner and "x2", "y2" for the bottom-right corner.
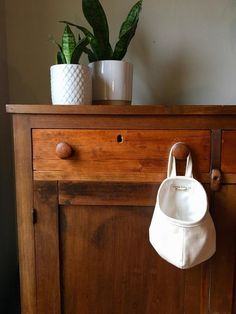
[{"x1": 50, "y1": 64, "x2": 92, "y2": 105}]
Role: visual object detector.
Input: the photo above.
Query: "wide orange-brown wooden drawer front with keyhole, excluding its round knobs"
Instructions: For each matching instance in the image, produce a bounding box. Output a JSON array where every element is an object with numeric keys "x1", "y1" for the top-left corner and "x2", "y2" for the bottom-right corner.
[{"x1": 32, "y1": 129, "x2": 210, "y2": 182}]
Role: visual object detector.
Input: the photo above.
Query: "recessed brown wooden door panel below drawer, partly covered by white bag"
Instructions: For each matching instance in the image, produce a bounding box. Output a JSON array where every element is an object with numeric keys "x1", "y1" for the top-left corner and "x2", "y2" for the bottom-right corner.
[{"x1": 60, "y1": 206, "x2": 207, "y2": 314}]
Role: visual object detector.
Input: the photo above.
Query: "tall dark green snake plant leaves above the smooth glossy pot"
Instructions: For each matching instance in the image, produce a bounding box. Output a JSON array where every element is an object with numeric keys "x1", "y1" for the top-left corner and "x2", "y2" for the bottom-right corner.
[{"x1": 62, "y1": 0, "x2": 143, "y2": 62}]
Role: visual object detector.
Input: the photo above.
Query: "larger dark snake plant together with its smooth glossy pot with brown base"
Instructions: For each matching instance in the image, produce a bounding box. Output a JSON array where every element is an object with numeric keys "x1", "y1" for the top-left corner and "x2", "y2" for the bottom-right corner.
[{"x1": 63, "y1": 0, "x2": 142, "y2": 104}]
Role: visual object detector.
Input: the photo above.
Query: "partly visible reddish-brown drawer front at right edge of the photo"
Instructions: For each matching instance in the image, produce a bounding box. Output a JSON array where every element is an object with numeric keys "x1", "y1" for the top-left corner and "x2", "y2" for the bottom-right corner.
[{"x1": 221, "y1": 131, "x2": 236, "y2": 173}]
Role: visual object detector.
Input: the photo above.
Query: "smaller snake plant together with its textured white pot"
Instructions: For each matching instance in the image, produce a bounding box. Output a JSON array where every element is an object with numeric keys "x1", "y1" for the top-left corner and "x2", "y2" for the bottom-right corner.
[{"x1": 50, "y1": 24, "x2": 92, "y2": 105}]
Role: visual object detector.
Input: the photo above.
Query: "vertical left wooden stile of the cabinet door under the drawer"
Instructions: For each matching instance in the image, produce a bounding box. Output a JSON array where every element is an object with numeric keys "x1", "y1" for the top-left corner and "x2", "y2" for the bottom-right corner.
[{"x1": 34, "y1": 181, "x2": 61, "y2": 314}]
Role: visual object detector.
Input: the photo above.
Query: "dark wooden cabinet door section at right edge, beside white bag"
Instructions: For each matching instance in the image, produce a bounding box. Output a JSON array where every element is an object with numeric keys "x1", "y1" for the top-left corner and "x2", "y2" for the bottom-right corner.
[{"x1": 210, "y1": 185, "x2": 236, "y2": 314}]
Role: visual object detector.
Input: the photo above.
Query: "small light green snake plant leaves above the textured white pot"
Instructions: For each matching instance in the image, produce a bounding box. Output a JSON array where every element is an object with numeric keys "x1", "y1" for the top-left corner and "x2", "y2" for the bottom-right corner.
[{"x1": 53, "y1": 24, "x2": 89, "y2": 64}]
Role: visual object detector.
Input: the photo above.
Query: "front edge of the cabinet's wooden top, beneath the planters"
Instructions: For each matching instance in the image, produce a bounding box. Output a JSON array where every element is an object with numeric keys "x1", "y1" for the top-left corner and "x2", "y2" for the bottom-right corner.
[{"x1": 6, "y1": 104, "x2": 236, "y2": 116}]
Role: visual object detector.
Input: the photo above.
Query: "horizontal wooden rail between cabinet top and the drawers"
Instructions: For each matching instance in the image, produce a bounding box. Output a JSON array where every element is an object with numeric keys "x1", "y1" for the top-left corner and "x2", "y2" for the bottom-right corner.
[{"x1": 24, "y1": 114, "x2": 236, "y2": 130}]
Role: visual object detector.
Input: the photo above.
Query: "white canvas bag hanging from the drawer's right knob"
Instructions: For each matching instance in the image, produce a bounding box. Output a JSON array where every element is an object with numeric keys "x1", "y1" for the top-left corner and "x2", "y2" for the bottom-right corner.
[{"x1": 149, "y1": 145, "x2": 216, "y2": 269}]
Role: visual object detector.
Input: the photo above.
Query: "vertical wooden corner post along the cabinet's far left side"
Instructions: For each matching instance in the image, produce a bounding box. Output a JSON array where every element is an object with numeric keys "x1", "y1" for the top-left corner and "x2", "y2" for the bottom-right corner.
[{"x1": 13, "y1": 115, "x2": 36, "y2": 314}]
